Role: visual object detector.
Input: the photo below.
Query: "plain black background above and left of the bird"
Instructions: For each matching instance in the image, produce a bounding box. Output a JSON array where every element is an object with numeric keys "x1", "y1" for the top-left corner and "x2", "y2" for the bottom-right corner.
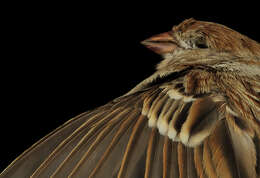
[{"x1": 0, "y1": 2, "x2": 260, "y2": 172}]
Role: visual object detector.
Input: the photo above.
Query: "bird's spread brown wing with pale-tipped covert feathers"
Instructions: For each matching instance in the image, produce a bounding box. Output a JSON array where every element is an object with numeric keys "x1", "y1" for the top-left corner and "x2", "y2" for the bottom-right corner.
[{"x1": 0, "y1": 69, "x2": 260, "y2": 178}]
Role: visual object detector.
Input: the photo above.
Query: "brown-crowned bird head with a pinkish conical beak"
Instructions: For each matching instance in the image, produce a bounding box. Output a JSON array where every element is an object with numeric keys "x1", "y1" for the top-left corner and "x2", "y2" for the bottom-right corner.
[{"x1": 142, "y1": 18, "x2": 260, "y2": 56}]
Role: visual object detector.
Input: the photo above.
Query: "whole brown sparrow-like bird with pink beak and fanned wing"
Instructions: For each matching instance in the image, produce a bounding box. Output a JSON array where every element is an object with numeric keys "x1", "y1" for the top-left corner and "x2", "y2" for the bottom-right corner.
[{"x1": 0, "y1": 18, "x2": 260, "y2": 178}]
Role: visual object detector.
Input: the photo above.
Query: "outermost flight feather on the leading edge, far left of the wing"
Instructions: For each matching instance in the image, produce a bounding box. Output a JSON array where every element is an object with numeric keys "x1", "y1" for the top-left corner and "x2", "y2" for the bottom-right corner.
[{"x1": 0, "y1": 112, "x2": 97, "y2": 177}]
